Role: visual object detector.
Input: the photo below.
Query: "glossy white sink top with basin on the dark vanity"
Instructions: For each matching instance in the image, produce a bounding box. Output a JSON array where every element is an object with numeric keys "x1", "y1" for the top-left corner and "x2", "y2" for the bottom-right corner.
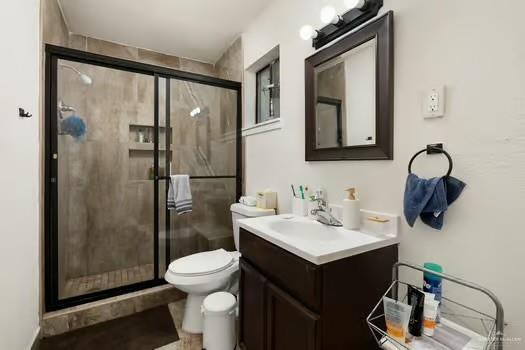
[{"x1": 239, "y1": 215, "x2": 399, "y2": 265}]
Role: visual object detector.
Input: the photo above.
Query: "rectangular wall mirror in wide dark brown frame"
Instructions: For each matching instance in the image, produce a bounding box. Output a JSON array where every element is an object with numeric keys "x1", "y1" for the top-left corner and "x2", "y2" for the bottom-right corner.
[{"x1": 305, "y1": 12, "x2": 394, "y2": 161}]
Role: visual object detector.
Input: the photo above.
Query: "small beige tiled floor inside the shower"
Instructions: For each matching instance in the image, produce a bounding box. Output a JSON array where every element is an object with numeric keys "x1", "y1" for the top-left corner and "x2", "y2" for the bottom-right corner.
[{"x1": 61, "y1": 264, "x2": 153, "y2": 298}]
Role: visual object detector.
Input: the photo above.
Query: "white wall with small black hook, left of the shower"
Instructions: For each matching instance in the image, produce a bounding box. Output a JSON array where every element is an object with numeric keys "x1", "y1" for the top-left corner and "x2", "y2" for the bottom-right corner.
[{"x1": 0, "y1": 0, "x2": 40, "y2": 350}]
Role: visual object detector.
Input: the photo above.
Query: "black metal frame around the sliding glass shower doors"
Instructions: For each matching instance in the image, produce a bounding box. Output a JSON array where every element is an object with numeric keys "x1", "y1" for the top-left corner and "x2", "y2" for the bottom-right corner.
[{"x1": 44, "y1": 44, "x2": 242, "y2": 311}]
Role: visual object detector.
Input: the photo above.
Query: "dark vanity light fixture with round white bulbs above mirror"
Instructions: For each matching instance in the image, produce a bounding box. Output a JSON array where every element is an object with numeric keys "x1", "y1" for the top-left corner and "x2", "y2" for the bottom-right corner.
[{"x1": 299, "y1": 0, "x2": 383, "y2": 49}]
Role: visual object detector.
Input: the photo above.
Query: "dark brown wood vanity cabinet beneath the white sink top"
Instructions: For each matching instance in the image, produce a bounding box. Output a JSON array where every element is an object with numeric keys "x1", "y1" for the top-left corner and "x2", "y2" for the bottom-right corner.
[{"x1": 239, "y1": 229, "x2": 397, "y2": 350}]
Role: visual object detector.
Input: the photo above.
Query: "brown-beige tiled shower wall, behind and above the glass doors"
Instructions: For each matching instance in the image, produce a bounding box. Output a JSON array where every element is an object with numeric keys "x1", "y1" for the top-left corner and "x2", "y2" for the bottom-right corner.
[{"x1": 42, "y1": 0, "x2": 242, "y2": 292}]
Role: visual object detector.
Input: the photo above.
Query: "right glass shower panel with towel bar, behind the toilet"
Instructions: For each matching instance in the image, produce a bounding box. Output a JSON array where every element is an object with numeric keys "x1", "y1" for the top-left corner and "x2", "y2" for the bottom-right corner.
[{"x1": 160, "y1": 79, "x2": 241, "y2": 270}]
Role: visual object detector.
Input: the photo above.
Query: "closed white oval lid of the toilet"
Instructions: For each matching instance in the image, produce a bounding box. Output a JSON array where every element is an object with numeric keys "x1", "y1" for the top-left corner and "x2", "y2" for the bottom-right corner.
[{"x1": 169, "y1": 249, "x2": 234, "y2": 276}]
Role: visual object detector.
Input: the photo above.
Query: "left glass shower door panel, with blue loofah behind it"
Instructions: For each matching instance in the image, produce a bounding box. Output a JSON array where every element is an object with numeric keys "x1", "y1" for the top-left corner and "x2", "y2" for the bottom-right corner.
[{"x1": 53, "y1": 59, "x2": 155, "y2": 299}]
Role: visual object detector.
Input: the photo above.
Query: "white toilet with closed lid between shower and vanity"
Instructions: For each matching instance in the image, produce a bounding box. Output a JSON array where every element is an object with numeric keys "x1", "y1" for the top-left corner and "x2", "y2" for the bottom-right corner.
[{"x1": 164, "y1": 203, "x2": 275, "y2": 333}]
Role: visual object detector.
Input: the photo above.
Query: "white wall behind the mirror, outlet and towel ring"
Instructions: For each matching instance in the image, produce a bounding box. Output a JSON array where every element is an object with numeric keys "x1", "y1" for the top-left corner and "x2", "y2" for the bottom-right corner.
[{"x1": 243, "y1": 0, "x2": 525, "y2": 349}]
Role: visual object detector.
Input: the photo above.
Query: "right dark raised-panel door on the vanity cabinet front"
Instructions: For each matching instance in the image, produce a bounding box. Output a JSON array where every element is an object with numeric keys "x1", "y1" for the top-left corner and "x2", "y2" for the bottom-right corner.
[{"x1": 266, "y1": 283, "x2": 320, "y2": 350}]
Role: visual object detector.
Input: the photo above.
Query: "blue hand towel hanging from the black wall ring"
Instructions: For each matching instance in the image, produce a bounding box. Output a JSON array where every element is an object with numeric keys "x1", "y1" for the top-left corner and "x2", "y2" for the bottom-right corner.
[{"x1": 403, "y1": 174, "x2": 466, "y2": 230}]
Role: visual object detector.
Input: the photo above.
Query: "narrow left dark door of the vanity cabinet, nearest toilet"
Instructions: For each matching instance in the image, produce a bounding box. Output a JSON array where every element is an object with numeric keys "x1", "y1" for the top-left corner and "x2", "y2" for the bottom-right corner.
[{"x1": 239, "y1": 258, "x2": 267, "y2": 350}]
